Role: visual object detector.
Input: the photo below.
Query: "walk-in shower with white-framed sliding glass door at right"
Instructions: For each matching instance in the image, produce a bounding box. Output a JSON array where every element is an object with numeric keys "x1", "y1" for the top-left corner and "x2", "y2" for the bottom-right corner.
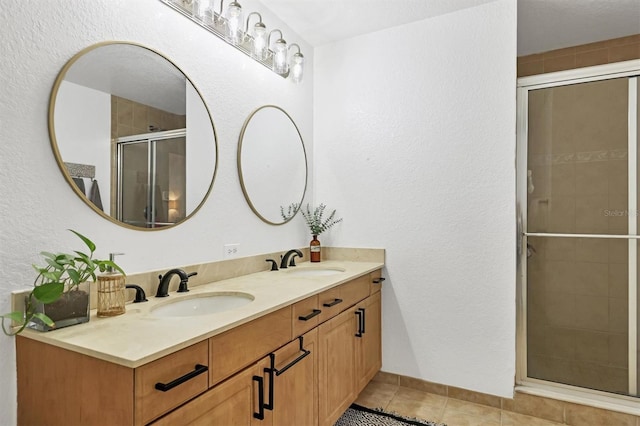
[{"x1": 517, "y1": 61, "x2": 640, "y2": 401}]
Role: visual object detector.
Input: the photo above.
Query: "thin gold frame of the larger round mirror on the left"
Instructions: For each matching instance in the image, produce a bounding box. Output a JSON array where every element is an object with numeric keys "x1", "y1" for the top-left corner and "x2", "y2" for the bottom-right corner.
[{"x1": 48, "y1": 41, "x2": 218, "y2": 231}]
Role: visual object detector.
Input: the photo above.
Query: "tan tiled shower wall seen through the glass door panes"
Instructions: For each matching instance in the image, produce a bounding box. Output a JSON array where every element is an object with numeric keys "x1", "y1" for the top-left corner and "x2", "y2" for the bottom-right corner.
[{"x1": 527, "y1": 79, "x2": 635, "y2": 393}]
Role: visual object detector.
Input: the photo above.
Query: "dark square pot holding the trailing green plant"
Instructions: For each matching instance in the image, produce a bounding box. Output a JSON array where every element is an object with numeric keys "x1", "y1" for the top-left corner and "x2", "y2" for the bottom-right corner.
[{"x1": 27, "y1": 282, "x2": 91, "y2": 331}]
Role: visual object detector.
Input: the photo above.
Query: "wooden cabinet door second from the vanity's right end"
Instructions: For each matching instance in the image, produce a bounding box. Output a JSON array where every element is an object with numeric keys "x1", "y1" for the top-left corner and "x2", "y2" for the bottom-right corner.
[{"x1": 318, "y1": 307, "x2": 357, "y2": 426}]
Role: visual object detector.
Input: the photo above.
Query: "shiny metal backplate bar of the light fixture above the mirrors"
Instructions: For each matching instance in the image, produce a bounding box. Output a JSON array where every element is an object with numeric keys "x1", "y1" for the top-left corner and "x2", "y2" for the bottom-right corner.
[{"x1": 160, "y1": 0, "x2": 298, "y2": 82}]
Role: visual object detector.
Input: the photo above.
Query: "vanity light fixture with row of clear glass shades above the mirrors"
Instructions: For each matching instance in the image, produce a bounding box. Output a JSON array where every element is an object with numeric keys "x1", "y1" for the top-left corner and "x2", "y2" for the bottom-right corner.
[{"x1": 160, "y1": 0, "x2": 304, "y2": 83}]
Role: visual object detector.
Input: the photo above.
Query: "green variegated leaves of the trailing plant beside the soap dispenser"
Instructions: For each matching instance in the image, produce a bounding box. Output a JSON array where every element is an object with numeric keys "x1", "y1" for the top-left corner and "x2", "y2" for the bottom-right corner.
[{"x1": 0, "y1": 229, "x2": 124, "y2": 336}]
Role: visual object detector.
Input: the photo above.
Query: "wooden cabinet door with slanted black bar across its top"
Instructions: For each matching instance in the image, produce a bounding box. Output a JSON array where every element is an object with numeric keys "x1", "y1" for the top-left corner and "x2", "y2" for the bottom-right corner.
[{"x1": 265, "y1": 329, "x2": 318, "y2": 426}]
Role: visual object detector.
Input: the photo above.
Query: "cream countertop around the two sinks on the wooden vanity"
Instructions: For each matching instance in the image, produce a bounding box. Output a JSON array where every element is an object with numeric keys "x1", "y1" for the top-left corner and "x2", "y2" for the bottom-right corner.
[{"x1": 22, "y1": 260, "x2": 384, "y2": 368}]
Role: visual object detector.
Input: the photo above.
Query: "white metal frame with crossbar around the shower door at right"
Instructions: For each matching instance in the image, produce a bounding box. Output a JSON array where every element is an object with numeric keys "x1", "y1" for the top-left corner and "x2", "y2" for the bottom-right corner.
[{"x1": 516, "y1": 60, "x2": 640, "y2": 406}]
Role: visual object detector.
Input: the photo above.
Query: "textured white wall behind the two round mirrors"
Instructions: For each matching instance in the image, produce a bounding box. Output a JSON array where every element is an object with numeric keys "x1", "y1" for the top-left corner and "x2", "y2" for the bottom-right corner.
[{"x1": 0, "y1": 0, "x2": 313, "y2": 425}]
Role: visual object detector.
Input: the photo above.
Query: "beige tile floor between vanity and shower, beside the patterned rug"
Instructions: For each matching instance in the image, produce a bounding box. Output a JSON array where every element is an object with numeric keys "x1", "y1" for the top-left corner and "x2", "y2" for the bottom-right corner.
[{"x1": 356, "y1": 381, "x2": 561, "y2": 426}]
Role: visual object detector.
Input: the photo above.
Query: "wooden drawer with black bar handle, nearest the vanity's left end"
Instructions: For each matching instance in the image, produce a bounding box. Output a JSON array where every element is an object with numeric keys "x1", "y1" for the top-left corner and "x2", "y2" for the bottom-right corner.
[{"x1": 134, "y1": 341, "x2": 209, "y2": 424}]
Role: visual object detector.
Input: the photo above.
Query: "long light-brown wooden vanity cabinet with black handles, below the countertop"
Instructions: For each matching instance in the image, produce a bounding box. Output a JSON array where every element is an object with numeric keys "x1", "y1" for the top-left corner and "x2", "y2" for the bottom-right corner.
[{"x1": 16, "y1": 271, "x2": 381, "y2": 426}]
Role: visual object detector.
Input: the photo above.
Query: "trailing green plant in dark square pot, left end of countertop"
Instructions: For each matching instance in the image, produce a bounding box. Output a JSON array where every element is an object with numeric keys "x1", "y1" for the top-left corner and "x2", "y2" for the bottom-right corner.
[{"x1": 1, "y1": 229, "x2": 124, "y2": 336}]
